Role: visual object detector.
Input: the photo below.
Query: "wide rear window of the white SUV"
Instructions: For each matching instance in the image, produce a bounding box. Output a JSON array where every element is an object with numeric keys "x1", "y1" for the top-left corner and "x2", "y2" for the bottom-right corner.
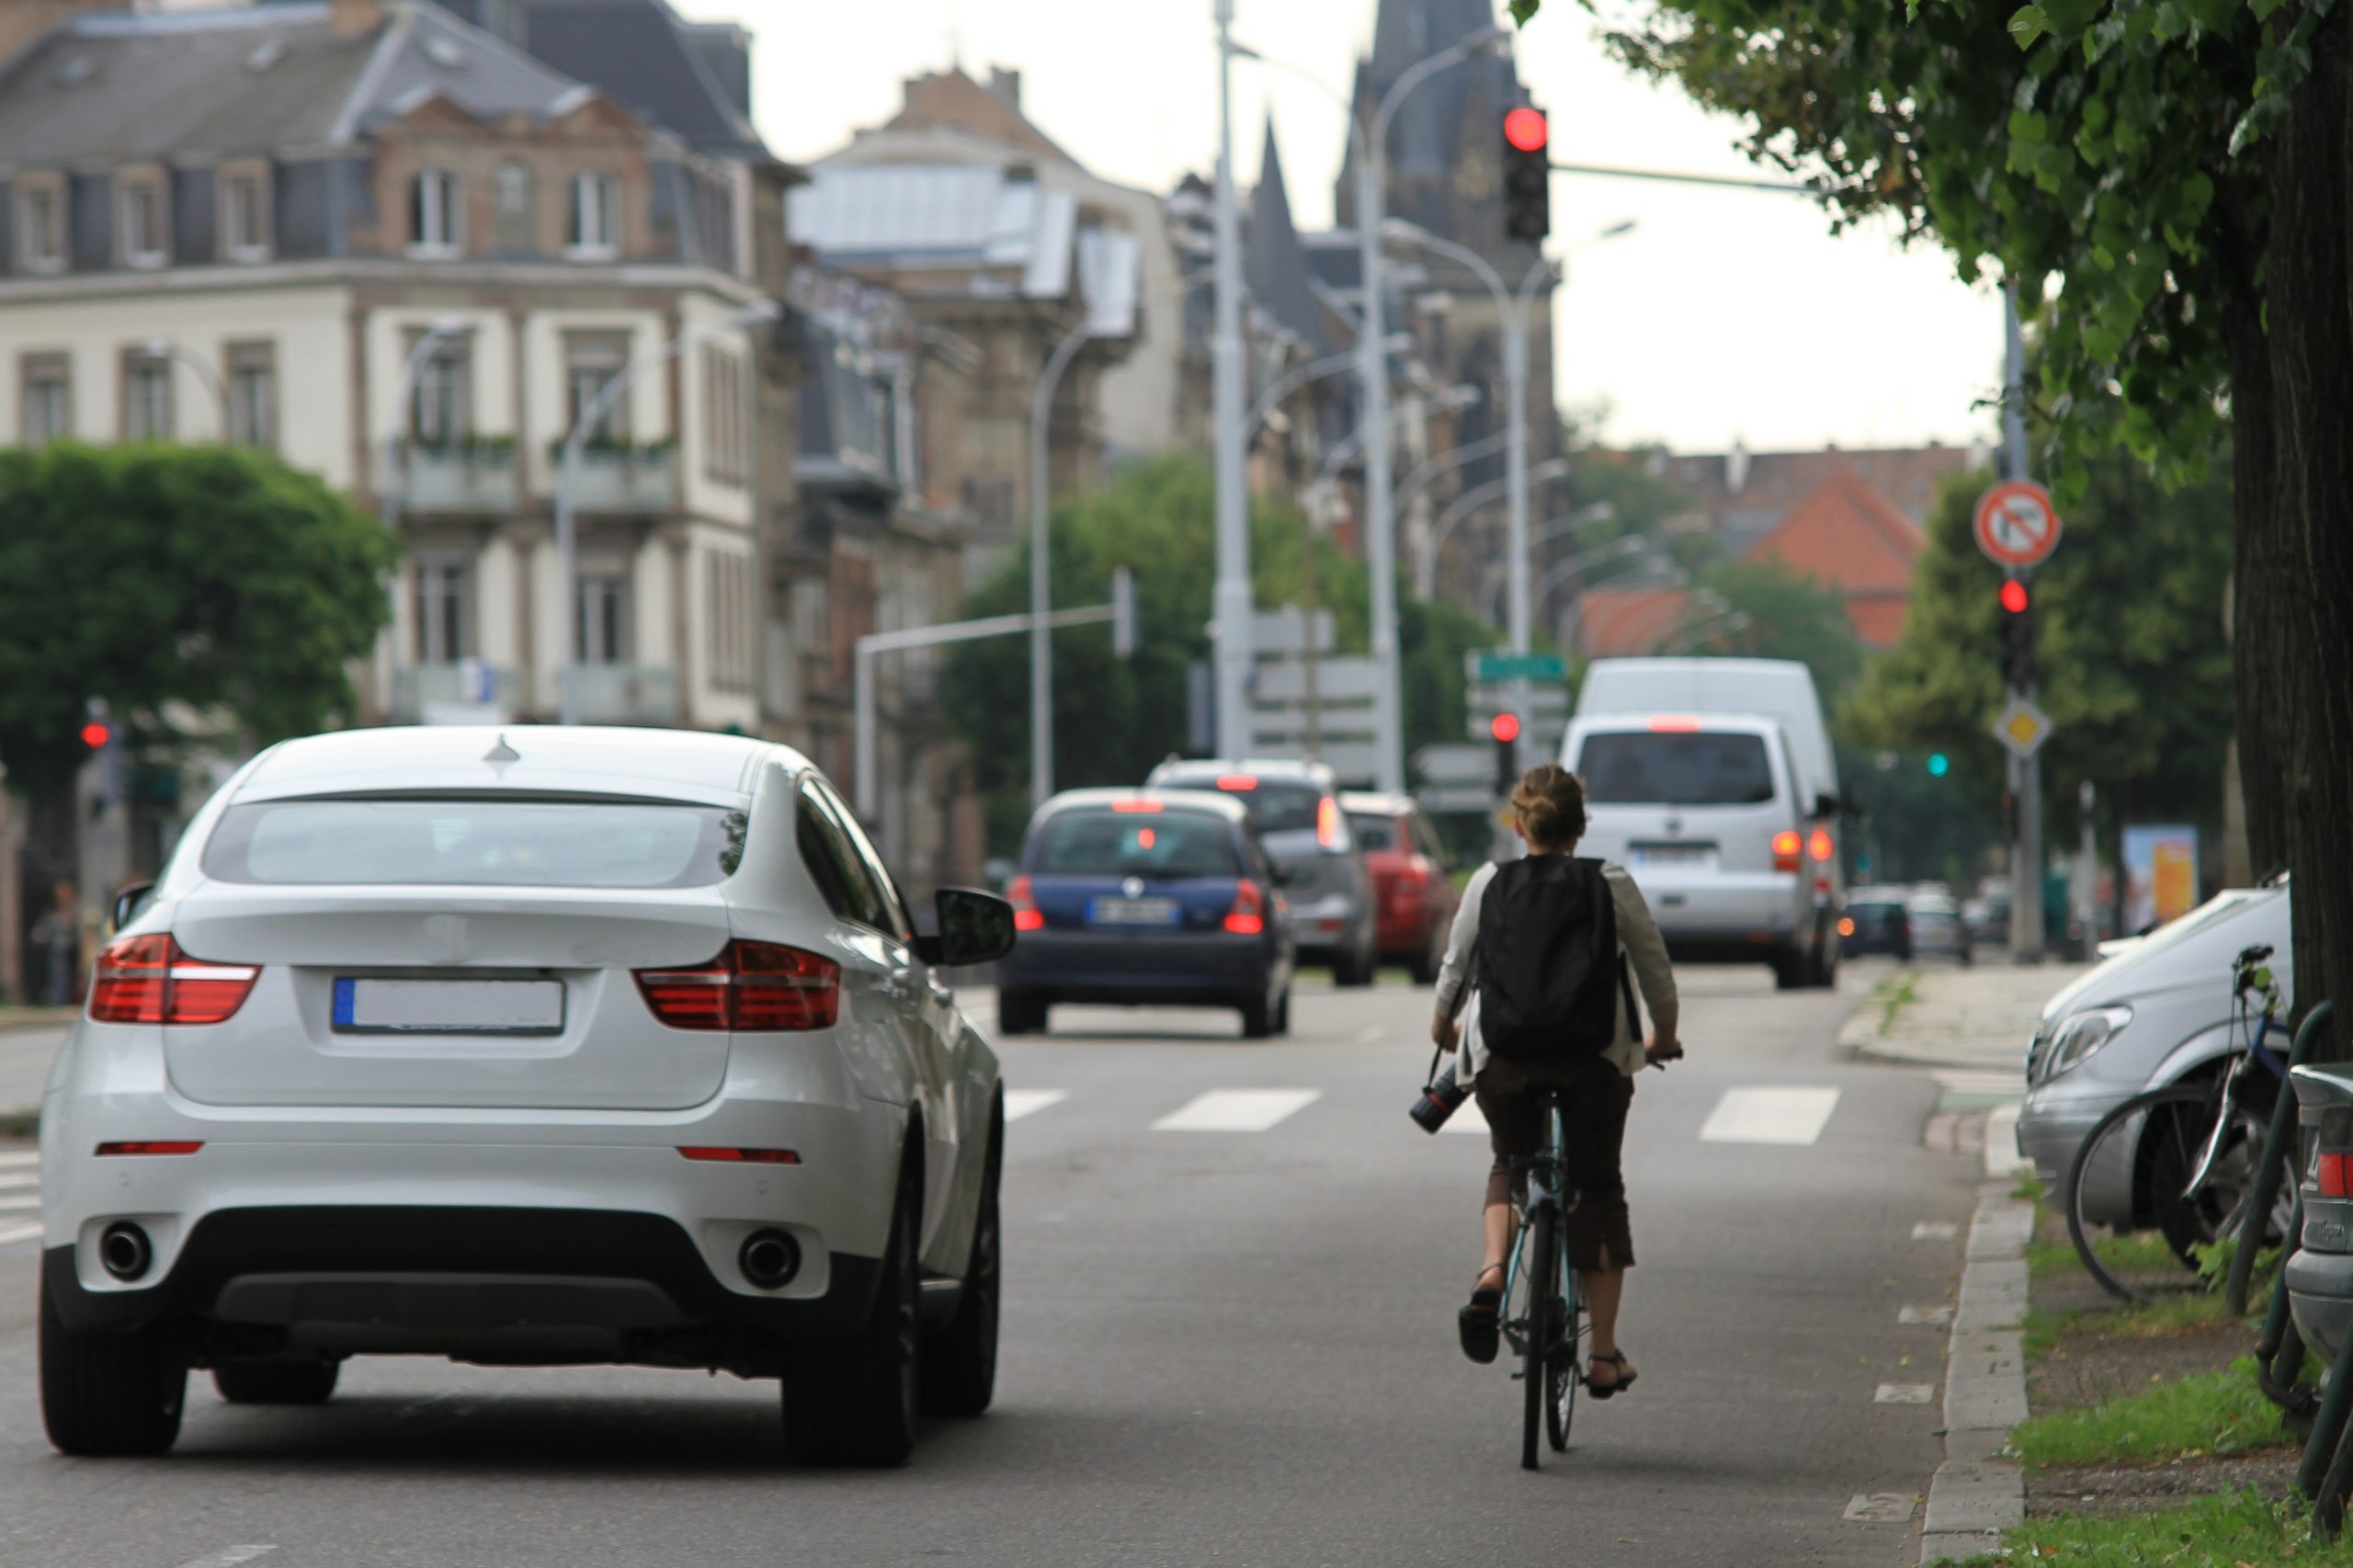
[{"x1": 202, "y1": 796, "x2": 744, "y2": 888}]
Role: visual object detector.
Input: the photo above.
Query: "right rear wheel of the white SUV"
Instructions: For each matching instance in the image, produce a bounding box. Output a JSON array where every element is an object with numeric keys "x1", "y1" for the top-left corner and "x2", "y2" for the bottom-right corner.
[{"x1": 783, "y1": 1125, "x2": 923, "y2": 1467}]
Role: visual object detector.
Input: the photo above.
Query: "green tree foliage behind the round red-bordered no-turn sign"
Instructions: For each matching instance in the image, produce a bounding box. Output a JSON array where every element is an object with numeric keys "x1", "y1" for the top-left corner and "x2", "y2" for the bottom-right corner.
[{"x1": 1842, "y1": 457, "x2": 2231, "y2": 824}]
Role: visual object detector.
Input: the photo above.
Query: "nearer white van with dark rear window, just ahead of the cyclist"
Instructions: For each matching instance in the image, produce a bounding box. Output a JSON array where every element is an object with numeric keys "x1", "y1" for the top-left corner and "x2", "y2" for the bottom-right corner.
[{"x1": 1560, "y1": 713, "x2": 1840, "y2": 991}]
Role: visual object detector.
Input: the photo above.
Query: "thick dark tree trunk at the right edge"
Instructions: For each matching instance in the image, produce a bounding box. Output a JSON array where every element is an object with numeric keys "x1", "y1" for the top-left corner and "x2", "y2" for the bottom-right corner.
[{"x1": 2245, "y1": 7, "x2": 2353, "y2": 1036}]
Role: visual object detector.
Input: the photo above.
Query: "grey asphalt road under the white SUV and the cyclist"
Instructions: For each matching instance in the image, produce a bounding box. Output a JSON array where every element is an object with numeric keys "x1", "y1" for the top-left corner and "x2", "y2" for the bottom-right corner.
[{"x1": 0, "y1": 970, "x2": 1974, "y2": 1568}]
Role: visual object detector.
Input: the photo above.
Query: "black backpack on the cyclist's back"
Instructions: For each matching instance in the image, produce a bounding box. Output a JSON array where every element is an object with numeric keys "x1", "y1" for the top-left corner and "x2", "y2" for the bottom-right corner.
[{"x1": 1478, "y1": 855, "x2": 1633, "y2": 1062}]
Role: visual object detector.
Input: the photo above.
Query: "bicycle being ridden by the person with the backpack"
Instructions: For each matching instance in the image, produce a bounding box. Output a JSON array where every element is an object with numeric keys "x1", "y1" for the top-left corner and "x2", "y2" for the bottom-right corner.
[{"x1": 1504, "y1": 1090, "x2": 1586, "y2": 1469}]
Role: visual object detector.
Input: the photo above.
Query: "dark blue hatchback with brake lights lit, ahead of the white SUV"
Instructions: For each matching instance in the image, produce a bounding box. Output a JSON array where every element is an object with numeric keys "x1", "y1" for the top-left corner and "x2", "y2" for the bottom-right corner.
[{"x1": 997, "y1": 789, "x2": 1297, "y2": 1040}]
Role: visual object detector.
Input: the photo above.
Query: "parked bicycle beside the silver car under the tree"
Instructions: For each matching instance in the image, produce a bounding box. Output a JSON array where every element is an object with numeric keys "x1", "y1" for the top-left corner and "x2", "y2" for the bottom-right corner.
[{"x1": 2062, "y1": 947, "x2": 2297, "y2": 1302}]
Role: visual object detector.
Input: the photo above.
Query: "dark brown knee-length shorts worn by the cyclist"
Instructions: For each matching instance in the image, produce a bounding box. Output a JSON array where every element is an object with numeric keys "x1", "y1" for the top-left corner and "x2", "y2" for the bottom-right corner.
[{"x1": 1475, "y1": 1057, "x2": 1633, "y2": 1269}]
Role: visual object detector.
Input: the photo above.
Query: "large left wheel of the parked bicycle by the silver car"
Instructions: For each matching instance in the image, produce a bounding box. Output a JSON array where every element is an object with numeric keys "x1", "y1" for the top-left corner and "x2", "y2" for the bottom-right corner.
[{"x1": 2062, "y1": 1083, "x2": 2297, "y2": 1302}]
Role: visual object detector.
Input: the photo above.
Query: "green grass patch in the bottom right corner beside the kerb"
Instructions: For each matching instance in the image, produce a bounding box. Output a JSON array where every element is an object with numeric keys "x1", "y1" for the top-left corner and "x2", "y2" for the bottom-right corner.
[{"x1": 1946, "y1": 1490, "x2": 2353, "y2": 1568}]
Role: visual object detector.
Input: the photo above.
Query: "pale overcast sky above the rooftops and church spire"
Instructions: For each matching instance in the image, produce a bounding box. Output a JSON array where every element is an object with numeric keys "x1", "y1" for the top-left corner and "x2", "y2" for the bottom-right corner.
[{"x1": 676, "y1": 0, "x2": 2003, "y2": 449}]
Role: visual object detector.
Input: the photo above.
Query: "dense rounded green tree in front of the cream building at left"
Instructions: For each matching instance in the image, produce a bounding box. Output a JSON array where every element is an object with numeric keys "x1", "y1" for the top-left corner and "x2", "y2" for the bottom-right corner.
[{"x1": 0, "y1": 443, "x2": 398, "y2": 796}]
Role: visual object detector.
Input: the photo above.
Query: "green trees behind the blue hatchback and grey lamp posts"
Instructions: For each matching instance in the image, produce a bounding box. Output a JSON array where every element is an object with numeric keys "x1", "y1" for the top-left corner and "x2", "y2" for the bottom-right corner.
[{"x1": 941, "y1": 457, "x2": 1499, "y2": 850}]
